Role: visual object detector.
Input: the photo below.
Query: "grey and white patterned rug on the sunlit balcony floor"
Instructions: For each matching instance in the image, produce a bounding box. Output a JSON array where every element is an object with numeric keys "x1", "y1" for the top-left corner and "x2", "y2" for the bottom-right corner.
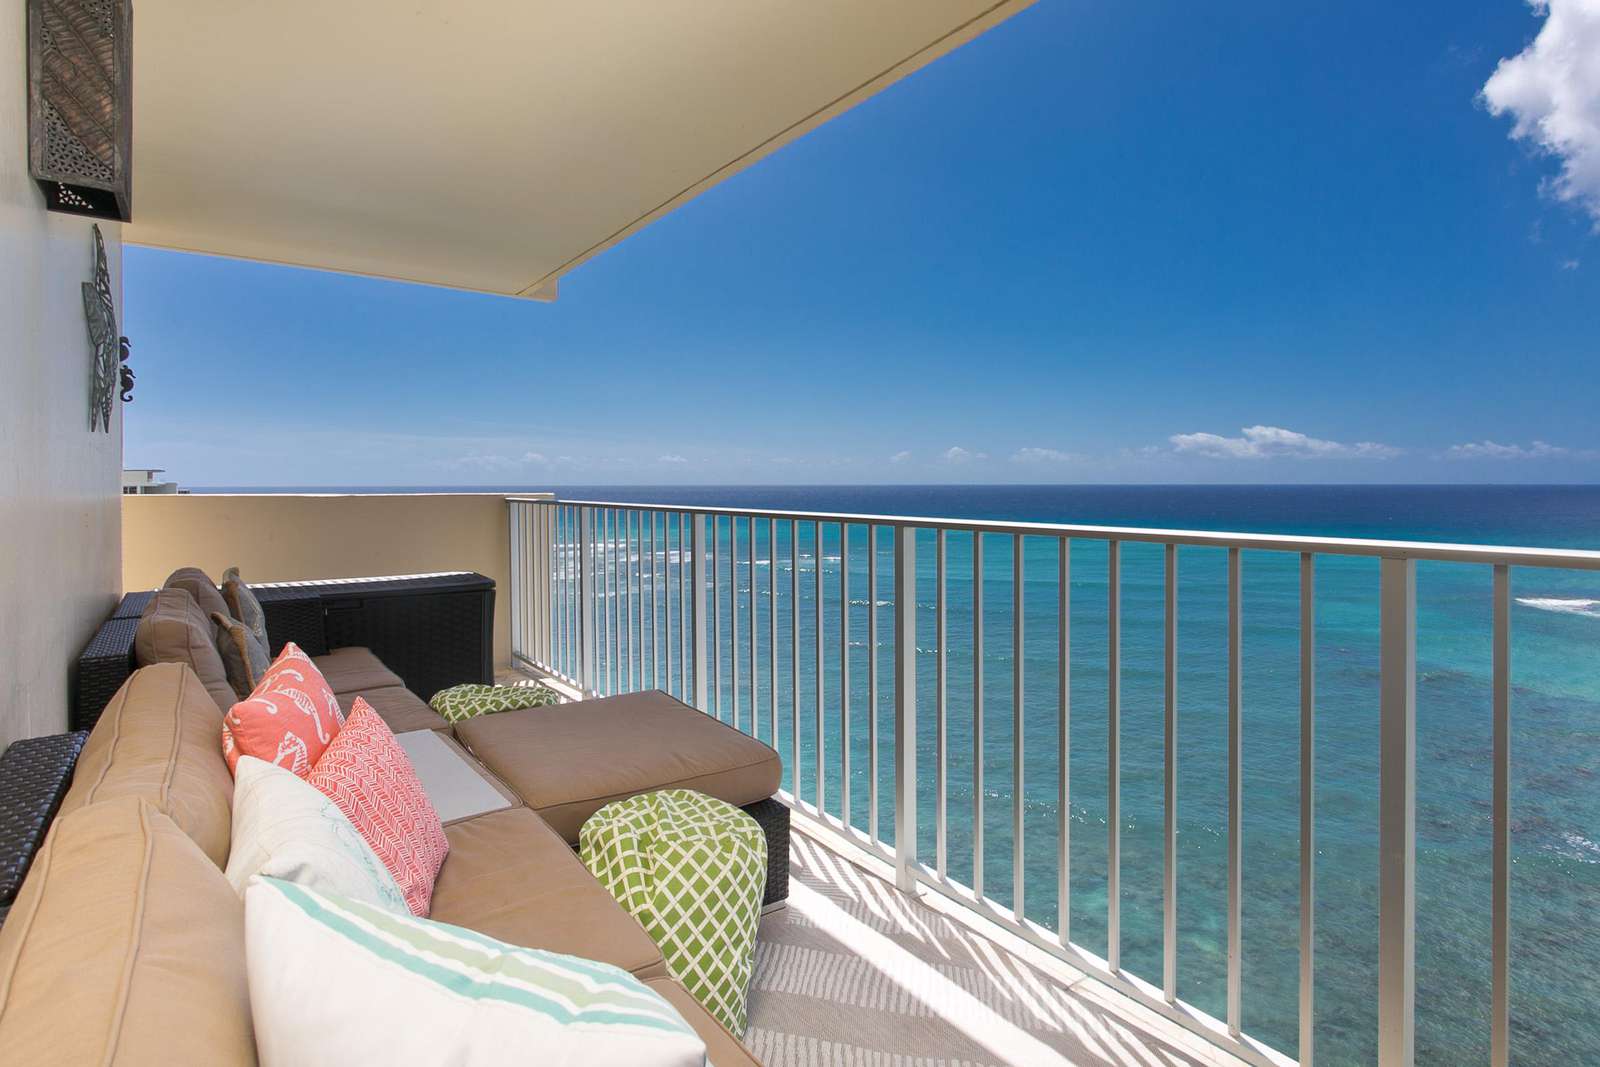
[{"x1": 746, "y1": 833, "x2": 1224, "y2": 1067}]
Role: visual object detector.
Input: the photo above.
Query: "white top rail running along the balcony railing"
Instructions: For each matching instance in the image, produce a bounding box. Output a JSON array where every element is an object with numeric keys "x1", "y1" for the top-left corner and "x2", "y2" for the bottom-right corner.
[{"x1": 506, "y1": 496, "x2": 1600, "y2": 571}]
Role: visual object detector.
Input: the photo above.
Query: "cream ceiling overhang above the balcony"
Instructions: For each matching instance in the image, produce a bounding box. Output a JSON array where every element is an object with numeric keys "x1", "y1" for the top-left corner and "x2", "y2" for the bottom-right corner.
[{"x1": 125, "y1": 0, "x2": 1032, "y2": 299}]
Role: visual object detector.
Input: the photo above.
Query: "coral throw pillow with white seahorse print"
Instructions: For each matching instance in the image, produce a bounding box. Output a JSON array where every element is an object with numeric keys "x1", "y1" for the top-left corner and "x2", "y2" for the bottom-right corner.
[{"x1": 222, "y1": 641, "x2": 344, "y2": 777}]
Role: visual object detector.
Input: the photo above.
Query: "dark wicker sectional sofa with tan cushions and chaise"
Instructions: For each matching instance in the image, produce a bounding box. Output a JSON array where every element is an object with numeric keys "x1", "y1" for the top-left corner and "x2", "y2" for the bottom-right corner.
[{"x1": 0, "y1": 571, "x2": 789, "y2": 1067}]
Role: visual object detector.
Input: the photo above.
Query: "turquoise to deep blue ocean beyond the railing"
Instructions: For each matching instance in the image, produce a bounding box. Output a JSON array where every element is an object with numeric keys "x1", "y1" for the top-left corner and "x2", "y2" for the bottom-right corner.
[{"x1": 216, "y1": 486, "x2": 1600, "y2": 1064}]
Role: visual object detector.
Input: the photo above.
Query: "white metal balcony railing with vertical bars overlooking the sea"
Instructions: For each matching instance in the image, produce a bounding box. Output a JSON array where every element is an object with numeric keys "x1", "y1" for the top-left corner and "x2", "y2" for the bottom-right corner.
[{"x1": 510, "y1": 498, "x2": 1600, "y2": 1067}]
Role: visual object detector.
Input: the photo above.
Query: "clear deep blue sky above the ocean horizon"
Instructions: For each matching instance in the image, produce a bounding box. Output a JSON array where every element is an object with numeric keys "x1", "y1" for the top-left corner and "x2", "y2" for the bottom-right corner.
[{"x1": 125, "y1": 0, "x2": 1600, "y2": 486}]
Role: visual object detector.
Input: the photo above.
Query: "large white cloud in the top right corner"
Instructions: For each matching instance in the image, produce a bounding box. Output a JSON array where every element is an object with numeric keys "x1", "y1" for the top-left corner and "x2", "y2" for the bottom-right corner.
[{"x1": 1482, "y1": 0, "x2": 1600, "y2": 229}]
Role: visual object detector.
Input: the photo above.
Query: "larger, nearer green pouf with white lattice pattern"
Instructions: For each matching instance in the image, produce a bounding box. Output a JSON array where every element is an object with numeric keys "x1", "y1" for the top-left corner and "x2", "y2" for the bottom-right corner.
[{"x1": 578, "y1": 789, "x2": 766, "y2": 1035}]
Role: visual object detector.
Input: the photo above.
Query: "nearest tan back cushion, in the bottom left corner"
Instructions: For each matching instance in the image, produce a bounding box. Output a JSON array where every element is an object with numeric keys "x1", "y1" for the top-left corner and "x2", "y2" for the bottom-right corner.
[{"x1": 0, "y1": 797, "x2": 256, "y2": 1067}]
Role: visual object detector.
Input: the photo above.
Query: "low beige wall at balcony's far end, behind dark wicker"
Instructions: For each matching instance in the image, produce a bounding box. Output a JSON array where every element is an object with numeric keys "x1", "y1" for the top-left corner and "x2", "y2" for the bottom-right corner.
[{"x1": 122, "y1": 493, "x2": 544, "y2": 667}]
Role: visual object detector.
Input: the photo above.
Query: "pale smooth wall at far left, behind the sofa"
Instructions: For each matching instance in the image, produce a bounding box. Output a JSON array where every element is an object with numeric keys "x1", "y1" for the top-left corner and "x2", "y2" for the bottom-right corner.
[{"x1": 0, "y1": 0, "x2": 122, "y2": 749}]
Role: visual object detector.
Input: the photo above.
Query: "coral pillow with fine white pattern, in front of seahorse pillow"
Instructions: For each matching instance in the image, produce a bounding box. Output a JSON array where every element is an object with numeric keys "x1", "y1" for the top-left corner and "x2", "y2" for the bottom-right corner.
[{"x1": 307, "y1": 697, "x2": 450, "y2": 918}]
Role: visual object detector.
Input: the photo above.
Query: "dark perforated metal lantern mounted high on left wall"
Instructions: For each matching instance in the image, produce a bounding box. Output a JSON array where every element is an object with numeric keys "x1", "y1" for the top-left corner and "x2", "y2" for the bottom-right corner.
[{"x1": 27, "y1": 0, "x2": 133, "y2": 222}]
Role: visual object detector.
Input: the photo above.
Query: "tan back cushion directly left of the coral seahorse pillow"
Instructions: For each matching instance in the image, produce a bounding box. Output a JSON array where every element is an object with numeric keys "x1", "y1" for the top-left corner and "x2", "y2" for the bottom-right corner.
[{"x1": 61, "y1": 664, "x2": 234, "y2": 867}]
